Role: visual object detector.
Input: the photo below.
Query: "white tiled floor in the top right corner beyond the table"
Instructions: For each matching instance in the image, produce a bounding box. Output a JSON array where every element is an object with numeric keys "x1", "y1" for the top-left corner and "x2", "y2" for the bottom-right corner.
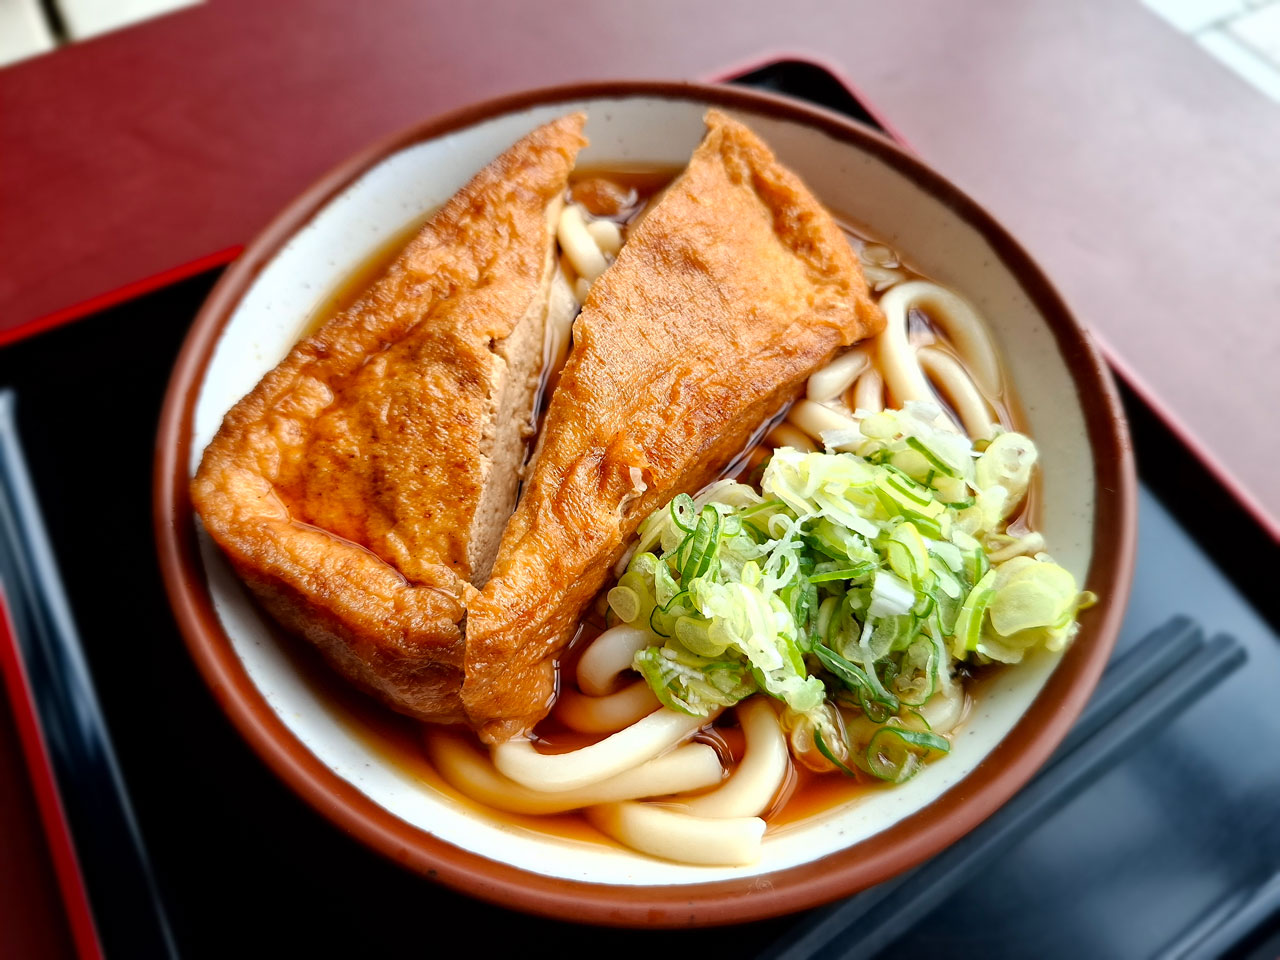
[{"x1": 1142, "y1": 0, "x2": 1280, "y2": 101}]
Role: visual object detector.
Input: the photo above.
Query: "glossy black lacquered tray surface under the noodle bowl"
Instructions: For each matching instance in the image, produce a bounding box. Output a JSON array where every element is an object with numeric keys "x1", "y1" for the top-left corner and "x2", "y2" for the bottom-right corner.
[{"x1": 0, "y1": 63, "x2": 1280, "y2": 957}]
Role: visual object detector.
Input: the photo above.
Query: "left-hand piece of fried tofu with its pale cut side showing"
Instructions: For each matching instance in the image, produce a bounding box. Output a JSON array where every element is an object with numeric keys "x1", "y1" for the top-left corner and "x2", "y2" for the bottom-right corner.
[{"x1": 192, "y1": 114, "x2": 585, "y2": 722}]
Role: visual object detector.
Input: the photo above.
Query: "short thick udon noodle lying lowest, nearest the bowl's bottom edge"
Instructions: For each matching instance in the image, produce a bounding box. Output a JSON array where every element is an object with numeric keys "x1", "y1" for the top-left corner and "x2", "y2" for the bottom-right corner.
[{"x1": 586, "y1": 803, "x2": 764, "y2": 867}]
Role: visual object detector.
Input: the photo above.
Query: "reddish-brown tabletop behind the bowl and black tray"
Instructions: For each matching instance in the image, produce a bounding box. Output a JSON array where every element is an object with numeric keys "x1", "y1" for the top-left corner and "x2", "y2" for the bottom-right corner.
[{"x1": 0, "y1": 0, "x2": 1280, "y2": 530}]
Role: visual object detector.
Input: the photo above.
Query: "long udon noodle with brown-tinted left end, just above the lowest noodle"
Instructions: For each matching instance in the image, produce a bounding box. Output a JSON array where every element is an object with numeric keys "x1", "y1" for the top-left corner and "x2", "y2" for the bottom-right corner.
[{"x1": 426, "y1": 732, "x2": 724, "y2": 817}]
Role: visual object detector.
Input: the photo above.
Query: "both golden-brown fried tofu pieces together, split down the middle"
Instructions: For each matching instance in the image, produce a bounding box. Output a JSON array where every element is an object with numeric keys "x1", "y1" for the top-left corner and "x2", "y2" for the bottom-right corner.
[{"x1": 192, "y1": 111, "x2": 884, "y2": 742}]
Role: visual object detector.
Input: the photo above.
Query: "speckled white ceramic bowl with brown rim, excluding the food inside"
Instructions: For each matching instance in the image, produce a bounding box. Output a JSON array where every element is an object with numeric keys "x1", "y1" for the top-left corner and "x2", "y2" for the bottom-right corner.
[{"x1": 156, "y1": 83, "x2": 1135, "y2": 925}]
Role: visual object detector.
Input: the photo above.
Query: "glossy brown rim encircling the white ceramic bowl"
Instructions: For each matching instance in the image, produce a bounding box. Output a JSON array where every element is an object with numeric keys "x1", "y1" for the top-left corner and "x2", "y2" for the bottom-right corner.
[{"x1": 154, "y1": 81, "x2": 1137, "y2": 927}]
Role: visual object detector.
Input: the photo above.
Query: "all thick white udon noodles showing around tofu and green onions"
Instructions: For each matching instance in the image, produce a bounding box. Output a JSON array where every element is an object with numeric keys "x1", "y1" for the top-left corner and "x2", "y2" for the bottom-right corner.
[{"x1": 412, "y1": 163, "x2": 1080, "y2": 864}]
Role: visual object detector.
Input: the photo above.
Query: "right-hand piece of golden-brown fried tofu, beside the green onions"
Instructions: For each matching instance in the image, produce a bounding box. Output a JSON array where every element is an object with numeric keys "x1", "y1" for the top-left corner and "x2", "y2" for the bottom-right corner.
[{"x1": 462, "y1": 111, "x2": 884, "y2": 742}]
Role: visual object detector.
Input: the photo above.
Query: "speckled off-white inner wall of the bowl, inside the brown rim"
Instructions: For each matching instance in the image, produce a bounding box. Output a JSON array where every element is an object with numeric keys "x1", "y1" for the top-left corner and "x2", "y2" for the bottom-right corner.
[{"x1": 191, "y1": 97, "x2": 1094, "y2": 884}]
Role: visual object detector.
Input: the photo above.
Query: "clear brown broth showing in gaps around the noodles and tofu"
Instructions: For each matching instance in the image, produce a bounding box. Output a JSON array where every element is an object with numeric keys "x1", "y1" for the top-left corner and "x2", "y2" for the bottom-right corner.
[{"x1": 293, "y1": 166, "x2": 1041, "y2": 849}]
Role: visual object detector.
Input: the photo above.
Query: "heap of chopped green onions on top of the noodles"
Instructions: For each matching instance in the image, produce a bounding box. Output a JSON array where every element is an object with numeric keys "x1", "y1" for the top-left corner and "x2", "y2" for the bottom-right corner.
[{"x1": 607, "y1": 403, "x2": 1093, "y2": 782}]
